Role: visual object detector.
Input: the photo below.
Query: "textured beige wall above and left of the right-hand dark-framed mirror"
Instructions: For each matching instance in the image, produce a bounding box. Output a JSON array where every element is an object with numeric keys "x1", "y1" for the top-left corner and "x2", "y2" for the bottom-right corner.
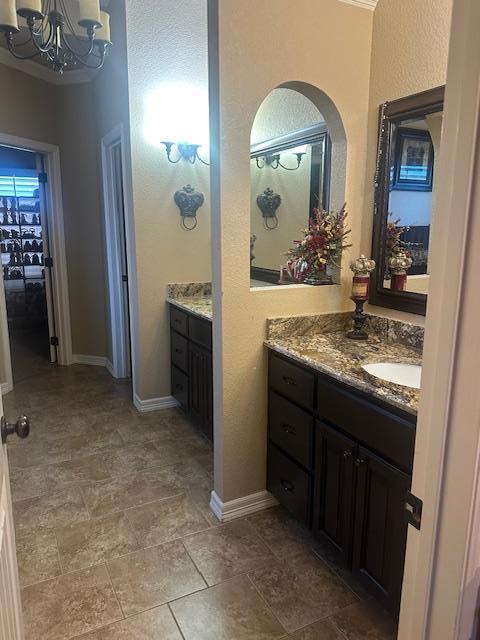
[{"x1": 362, "y1": 0, "x2": 453, "y2": 253}]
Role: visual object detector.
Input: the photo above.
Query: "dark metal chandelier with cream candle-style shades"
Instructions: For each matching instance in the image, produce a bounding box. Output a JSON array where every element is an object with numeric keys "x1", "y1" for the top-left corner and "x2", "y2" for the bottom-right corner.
[{"x1": 0, "y1": 0, "x2": 111, "y2": 74}]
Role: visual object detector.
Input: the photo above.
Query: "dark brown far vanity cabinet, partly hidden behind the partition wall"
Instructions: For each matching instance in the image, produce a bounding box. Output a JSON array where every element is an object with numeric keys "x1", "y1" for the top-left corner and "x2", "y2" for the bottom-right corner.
[{"x1": 170, "y1": 305, "x2": 213, "y2": 440}]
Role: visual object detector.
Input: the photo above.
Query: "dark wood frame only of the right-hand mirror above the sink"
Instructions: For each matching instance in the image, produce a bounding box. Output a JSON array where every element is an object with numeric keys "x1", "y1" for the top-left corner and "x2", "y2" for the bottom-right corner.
[{"x1": 370, "y1": 86, "x2": 445, "y2": 315}]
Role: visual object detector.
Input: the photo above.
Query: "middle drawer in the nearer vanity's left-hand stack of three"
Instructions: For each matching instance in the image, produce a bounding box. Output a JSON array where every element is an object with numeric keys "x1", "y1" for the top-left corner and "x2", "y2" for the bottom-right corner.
[{"x1": 269, "y1": 391, "x2": 313, "y2": 470}]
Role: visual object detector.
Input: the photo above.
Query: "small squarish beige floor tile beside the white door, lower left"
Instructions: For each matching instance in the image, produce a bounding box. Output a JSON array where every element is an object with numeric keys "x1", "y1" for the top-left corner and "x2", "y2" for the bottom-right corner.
[{"x1": 16, "y1": 531, "x2": 62, "y2": 587}]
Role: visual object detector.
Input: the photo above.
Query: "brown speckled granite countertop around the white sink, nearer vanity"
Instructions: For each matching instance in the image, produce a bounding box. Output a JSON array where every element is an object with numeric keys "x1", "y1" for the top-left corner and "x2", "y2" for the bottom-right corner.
[{"x1": 266, "y1": 320, "x2": 422, "y2": 415}]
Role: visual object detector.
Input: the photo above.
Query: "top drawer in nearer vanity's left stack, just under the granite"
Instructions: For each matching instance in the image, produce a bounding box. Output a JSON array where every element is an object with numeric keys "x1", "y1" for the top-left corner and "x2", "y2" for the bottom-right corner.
[{"x1": 270, "y1": 354, "x2": 315, "y2": 411}]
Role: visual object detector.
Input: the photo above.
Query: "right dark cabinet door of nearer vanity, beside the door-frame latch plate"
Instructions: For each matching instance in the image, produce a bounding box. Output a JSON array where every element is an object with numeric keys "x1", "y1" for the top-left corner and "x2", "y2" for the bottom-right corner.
[{"x1": 353, "y1": 447, "x2": 411, "y2": 613}]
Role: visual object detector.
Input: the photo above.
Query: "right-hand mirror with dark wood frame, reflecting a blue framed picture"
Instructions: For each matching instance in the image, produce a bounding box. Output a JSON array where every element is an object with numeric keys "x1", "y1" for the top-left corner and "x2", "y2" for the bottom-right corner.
[{"x1": 370, "y1": 87, "x2": 445, "y2": 315}]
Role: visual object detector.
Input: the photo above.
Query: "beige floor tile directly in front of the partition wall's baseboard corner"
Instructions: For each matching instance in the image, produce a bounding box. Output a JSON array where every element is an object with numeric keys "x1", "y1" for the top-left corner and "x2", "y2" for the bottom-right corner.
[{"x1": 183, "y1": 520, "x2": 275, "y2": 585}]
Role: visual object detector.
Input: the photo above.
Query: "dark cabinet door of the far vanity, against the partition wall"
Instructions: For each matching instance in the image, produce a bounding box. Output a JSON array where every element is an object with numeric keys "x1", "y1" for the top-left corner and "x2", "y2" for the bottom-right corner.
[{"x1": 188, "y1": 342, "x2": 213, "y2": 439}]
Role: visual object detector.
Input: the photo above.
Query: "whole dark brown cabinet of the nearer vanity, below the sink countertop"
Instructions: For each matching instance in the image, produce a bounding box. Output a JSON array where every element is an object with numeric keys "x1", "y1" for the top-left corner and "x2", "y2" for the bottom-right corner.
[{"x1": 268, "y1": 352, "x2": 415, "y2": 612}]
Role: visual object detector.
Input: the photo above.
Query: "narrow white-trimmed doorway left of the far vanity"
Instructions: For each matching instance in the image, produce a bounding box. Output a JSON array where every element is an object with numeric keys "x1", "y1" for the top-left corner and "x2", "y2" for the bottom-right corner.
[{"x1": 102, "y1": 125, "x2": 132, "y2": 378}]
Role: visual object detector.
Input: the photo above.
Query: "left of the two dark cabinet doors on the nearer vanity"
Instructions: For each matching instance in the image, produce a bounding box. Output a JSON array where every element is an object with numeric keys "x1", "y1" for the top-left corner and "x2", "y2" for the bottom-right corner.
[{"x1": 313, "y1": 422, "x2": 357, "y2": 565}]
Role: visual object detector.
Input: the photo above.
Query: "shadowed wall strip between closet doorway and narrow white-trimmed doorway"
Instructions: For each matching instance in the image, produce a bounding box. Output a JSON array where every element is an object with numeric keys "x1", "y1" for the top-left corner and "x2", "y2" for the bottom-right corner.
[{"x1": 57, "y1": 83, "x2": 107, "y2": 356}]
